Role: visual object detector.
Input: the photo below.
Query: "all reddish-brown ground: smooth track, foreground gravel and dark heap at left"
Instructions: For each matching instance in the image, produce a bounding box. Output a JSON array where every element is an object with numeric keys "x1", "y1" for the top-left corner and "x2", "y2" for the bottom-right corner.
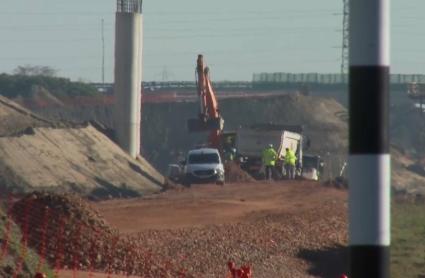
[{"x1": 11, "y1": 181, "x2": 348, "y2": 278}]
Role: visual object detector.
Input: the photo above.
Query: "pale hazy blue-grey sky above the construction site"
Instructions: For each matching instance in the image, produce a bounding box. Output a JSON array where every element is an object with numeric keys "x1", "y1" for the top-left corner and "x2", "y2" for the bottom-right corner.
[{"x1": 0, "y1": 0, "x2": 425, "y2": 82}]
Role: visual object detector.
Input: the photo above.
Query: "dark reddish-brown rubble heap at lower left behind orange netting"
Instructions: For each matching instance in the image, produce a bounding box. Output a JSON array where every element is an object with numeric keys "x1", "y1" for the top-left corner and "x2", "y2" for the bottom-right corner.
[{"x1": 12, "y1": 193, "x2": 187, "y2": 277}]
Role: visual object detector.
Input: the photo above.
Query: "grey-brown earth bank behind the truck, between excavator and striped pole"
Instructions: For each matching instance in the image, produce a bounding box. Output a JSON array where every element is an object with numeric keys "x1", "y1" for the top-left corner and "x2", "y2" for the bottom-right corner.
[{"x1": 220, "y1": 94, "x2": 348, "y2": 154}]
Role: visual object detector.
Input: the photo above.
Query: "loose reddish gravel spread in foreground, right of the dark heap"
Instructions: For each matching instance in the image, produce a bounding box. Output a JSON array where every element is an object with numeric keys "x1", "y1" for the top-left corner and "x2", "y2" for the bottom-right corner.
[{"x1": 132, "y1": 200, "x2": 347, "y2": 278}]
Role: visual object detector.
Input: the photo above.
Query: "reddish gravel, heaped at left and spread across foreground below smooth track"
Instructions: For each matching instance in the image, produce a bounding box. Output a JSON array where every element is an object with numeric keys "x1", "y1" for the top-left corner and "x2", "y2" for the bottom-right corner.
[{"x1": 9, "y1": 193, "x2": 347, "y2": 278}]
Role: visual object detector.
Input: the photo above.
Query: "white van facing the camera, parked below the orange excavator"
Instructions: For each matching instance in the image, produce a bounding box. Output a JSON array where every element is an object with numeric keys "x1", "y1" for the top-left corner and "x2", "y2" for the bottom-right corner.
[{"x1": 183, "y1": 148, "x2": 224, "y2": 186}]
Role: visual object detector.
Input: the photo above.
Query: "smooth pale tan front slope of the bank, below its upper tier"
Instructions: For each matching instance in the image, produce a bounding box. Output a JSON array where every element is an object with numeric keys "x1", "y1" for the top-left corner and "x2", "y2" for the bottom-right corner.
[{"x1": 0, "y1": 125, "x2": 163, "y2": 196}]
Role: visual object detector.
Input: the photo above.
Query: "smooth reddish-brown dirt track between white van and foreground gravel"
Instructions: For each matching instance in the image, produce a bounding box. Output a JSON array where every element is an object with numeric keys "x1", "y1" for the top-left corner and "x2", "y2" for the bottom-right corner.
[{"x1": 95, "y1": 181, "x2": 346, "y2": 233}]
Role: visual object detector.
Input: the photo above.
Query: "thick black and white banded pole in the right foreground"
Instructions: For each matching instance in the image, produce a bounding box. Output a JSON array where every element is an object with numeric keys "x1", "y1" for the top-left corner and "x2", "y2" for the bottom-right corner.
[{"x1": 349, "y1": 0, "x2": 390, "y2": 278}]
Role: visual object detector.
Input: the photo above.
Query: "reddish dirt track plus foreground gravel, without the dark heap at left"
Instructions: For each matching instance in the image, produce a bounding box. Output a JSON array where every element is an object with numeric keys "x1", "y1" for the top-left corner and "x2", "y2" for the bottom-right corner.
[{"x1": 94, "y1": 181, "x2": 347, "y2": 278}]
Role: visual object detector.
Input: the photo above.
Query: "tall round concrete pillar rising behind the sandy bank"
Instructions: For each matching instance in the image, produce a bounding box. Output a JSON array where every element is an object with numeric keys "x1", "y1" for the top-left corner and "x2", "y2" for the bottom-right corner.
[{"x1": 114, "y1": 0, "x2": 143, "y2": 158}]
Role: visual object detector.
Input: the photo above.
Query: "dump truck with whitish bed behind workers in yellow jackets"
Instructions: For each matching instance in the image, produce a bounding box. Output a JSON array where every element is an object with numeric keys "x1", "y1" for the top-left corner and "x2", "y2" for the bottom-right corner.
[{"x1": 235, "y1": 128, "x2": 303, "y2": 178}]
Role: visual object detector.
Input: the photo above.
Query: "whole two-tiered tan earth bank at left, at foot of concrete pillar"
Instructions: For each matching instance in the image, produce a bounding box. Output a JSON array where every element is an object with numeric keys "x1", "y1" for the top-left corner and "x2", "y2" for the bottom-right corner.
[{"x1": 0, "y1": 97, "x2": 164, "y2": 198}]
